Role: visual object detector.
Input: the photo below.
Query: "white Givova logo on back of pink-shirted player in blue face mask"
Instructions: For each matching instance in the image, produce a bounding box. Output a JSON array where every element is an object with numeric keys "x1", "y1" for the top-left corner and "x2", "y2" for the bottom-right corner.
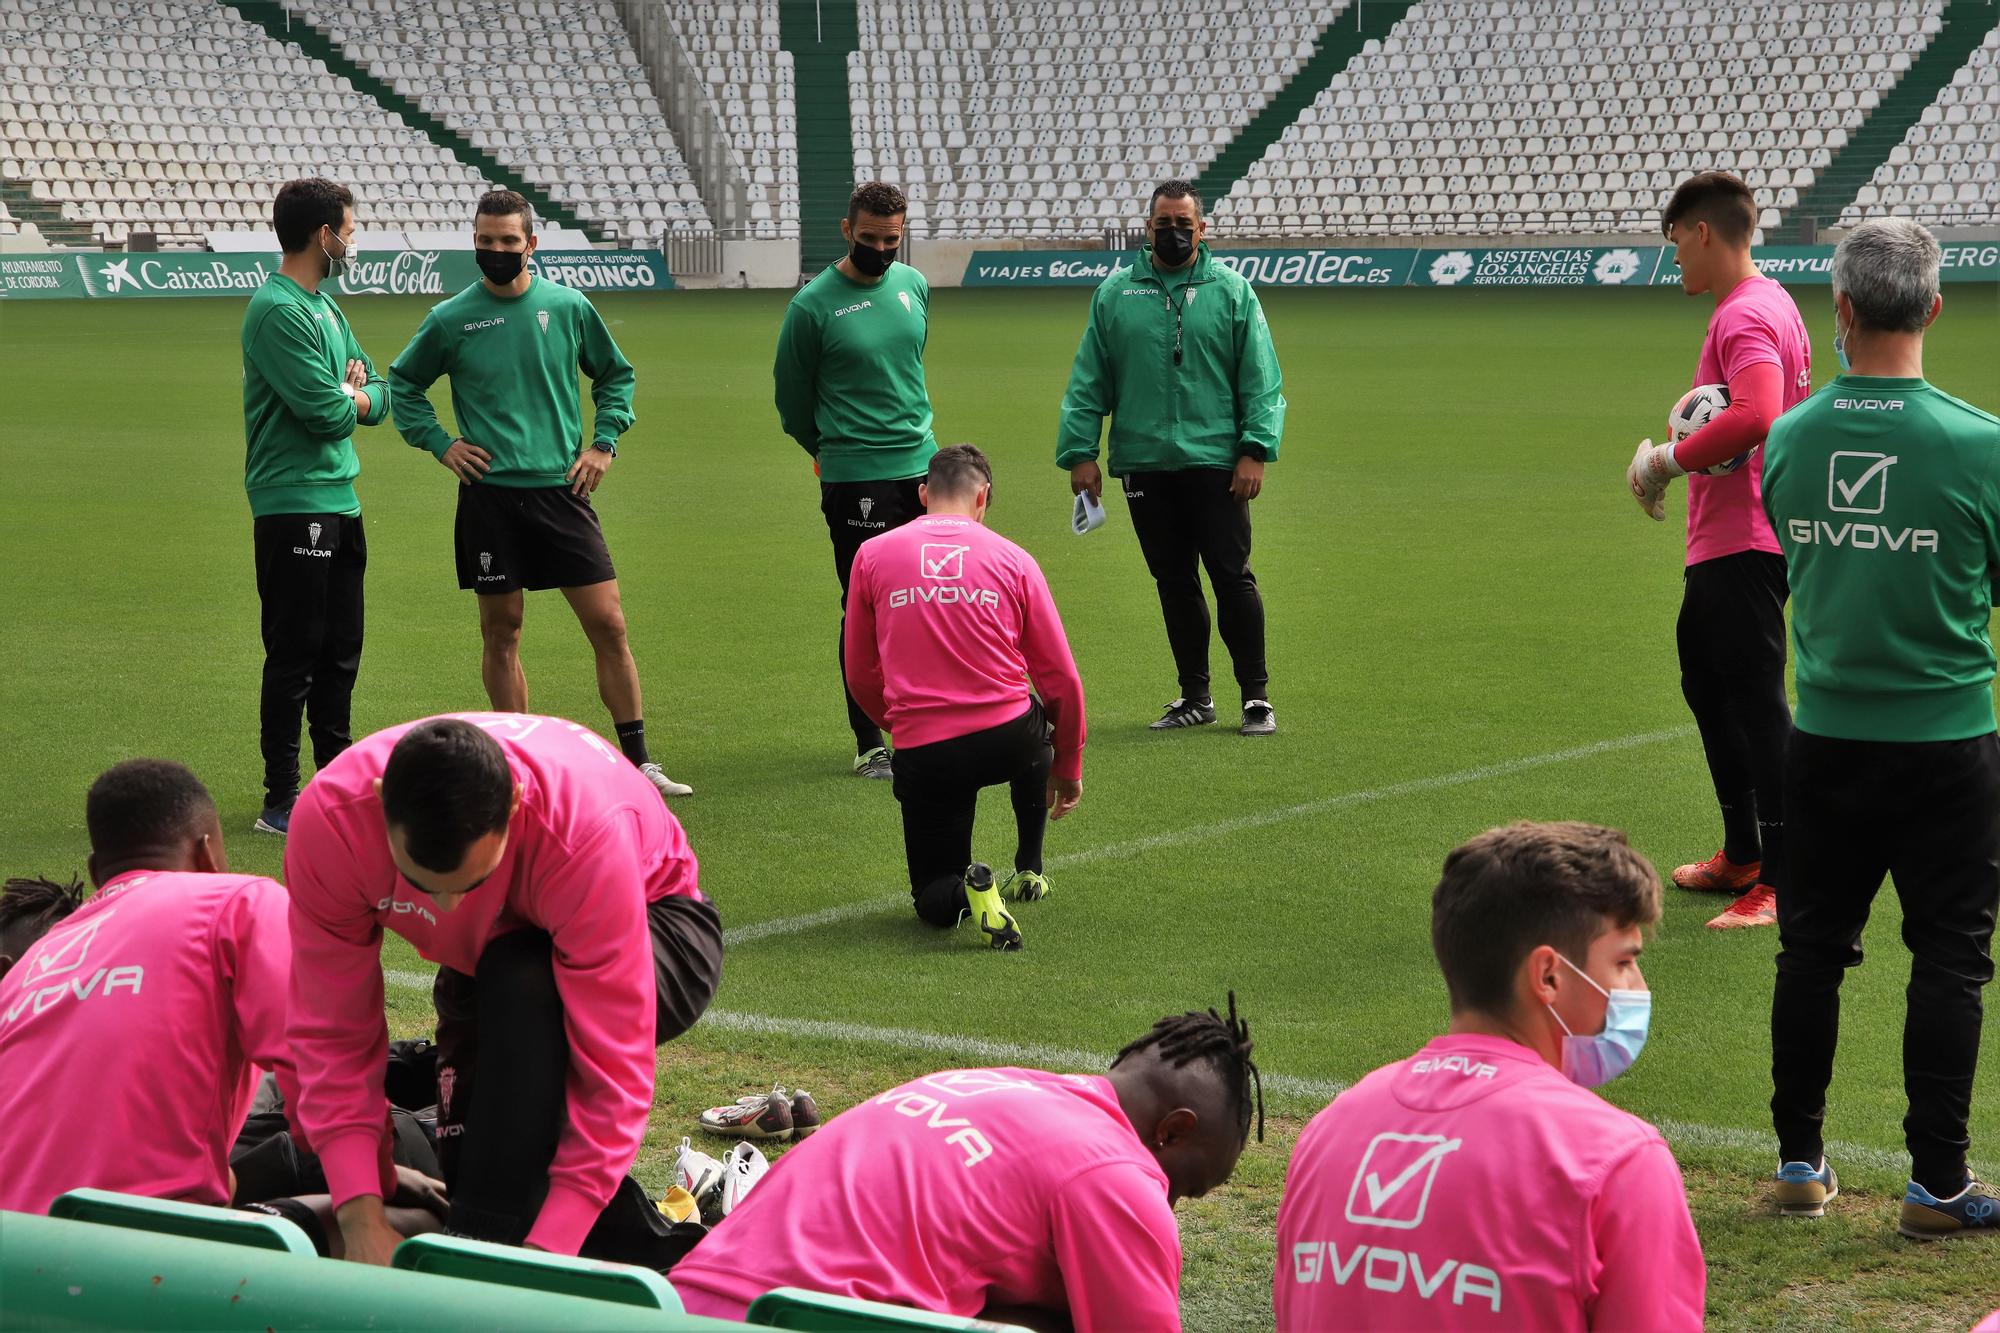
[{"x1": 1292, "y1": 1133, "x2": 1502, "y2": 1315}]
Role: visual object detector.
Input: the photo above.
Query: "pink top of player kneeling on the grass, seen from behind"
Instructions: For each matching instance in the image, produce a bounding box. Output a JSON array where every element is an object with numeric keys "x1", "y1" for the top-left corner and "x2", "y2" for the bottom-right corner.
[{"x1": 846, "y1": 514, "x2": 1084, "y2": 779}]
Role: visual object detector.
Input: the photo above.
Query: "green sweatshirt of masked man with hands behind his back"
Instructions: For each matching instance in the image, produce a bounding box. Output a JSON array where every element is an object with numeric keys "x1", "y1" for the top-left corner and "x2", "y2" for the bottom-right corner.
[{"x1": 772, "y1": 264, "x2": 938, "y2": 482}]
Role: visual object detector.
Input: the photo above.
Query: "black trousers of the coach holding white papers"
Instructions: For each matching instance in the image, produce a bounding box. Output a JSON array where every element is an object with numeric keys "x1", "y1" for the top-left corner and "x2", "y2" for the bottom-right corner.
[{"x1": 1124, "y1": 468, "x2": 1270, "y2": 701}]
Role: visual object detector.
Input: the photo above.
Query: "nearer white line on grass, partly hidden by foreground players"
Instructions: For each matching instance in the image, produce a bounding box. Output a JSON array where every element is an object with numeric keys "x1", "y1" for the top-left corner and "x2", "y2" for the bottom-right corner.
[{"x1": 384, "y1": 971, "x2": 1908, "y2": 1171}]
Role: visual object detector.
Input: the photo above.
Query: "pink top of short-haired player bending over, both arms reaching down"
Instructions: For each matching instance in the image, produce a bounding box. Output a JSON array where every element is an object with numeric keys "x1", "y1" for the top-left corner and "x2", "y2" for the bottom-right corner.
[{"x1": 284, "y1": 713, "x2": 700, "y2": 1255}]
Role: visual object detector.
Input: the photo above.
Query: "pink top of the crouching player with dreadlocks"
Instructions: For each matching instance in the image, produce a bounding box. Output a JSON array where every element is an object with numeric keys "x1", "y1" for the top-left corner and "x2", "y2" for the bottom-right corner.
[{"x1": 674, "y1": 1064, "x2": 1180, "y2": 1333}]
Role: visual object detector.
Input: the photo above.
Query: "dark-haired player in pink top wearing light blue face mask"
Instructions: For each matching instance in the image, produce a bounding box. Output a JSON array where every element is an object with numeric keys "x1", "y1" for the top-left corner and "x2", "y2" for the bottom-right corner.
[{"x1": 1274, "y1": 825, "x2": 1706, "y2": 1329}]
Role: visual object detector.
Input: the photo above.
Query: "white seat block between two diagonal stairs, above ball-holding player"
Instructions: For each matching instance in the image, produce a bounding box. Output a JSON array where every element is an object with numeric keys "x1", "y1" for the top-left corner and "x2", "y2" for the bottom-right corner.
[{"x1": 1216, "y1": 0, "x2": 1944, "y2": 236}]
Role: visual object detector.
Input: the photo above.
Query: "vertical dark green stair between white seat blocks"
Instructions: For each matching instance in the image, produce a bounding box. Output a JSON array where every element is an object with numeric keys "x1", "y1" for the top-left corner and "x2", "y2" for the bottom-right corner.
[{"x1": 778, "y1": 0, "x2": 860, "y2": 274}]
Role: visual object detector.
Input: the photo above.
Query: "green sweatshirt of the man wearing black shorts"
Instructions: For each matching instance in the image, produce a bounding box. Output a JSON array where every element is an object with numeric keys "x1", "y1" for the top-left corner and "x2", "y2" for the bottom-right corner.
[{"x1": 388, "y1": 278, "x2": 636, "y2": 486}]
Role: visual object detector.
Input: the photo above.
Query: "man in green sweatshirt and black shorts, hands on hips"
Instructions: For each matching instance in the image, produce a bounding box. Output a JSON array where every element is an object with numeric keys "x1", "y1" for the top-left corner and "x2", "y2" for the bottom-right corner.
[{"x1": 388, "y1": 190, "x2": 694, "y2": 797}]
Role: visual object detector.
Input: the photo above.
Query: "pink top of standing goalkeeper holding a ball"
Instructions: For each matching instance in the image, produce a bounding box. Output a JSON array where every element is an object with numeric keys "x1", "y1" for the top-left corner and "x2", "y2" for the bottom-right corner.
[{"x1": 1688, "y1": 274, "x2": 1812, "y2": 564}]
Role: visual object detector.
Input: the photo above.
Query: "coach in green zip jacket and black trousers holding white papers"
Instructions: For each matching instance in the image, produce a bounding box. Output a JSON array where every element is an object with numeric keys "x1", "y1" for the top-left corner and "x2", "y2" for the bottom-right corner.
[{"x1": 1056, "y1": 180, "x2": 1284, "y2": 737}]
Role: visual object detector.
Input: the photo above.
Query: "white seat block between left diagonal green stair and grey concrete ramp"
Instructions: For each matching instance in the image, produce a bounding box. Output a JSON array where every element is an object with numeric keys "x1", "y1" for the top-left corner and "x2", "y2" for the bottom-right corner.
[{"x1": 286, "y1": 0, "x2": 710, "y2": 244}]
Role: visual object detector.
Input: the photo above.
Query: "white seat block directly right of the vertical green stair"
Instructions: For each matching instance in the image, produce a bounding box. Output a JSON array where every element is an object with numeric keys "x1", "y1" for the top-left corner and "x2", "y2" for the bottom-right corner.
[{"x1": 848, "y1": 0, "x2": 1346, "y2": 236}]
